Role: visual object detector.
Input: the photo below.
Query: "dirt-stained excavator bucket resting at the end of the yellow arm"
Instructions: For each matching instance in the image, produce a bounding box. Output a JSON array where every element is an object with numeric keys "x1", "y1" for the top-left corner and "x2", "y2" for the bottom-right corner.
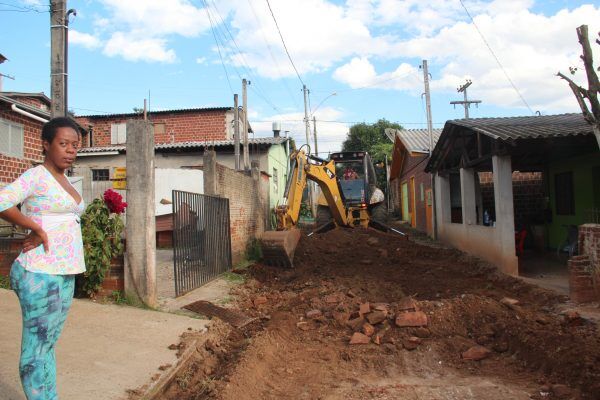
[{"x1": 261, "y1": 229, "x2": 300, "y2": 268}]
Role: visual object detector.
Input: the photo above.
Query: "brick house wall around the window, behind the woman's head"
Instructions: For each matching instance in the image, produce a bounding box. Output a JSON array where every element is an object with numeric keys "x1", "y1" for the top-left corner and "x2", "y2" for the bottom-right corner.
[{"x1": 0, "y1": 104, "x2": 43, "y2": 186}]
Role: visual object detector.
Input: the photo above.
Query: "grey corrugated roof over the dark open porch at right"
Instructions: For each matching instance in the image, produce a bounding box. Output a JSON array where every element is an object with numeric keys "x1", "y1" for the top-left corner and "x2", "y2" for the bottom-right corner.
[{"x1": 444, "y1": 113, "x2": 592, "y2": 140}]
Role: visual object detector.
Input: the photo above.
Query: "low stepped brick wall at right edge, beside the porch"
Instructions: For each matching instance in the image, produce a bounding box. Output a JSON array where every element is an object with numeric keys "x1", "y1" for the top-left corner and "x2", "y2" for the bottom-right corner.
[{"x1": 569, "y1": 224, "x2": 600, "y2": 303}]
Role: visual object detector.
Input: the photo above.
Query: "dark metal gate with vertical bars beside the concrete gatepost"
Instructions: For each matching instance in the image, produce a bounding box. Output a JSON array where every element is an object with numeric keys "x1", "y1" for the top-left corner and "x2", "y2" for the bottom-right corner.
[{"x1": 173, "y1": 190, "x2": 231, "y2": 296}]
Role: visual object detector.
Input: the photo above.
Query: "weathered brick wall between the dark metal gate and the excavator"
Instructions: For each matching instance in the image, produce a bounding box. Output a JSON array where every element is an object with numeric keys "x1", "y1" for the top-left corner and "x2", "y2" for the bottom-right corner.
[{"x1": 204, "y1": 151, "x2": 268, "y2": 264}]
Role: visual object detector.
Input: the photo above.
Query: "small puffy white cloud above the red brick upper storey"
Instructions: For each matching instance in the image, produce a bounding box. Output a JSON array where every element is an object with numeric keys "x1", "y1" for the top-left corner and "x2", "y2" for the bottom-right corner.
[{"x1": 104, "y1": 32, "x2": 176, "y2": 63}]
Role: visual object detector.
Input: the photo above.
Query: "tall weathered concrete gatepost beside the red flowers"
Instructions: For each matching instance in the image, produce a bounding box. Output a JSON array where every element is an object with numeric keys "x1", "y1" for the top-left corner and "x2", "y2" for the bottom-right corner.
[{"x1": 125, "y1": 120, "x2": 157, "y2": 307}]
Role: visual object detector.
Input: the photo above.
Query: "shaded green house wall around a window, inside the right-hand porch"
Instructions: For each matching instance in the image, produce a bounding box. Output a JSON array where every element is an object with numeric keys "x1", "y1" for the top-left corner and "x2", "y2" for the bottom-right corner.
[{"x1": 548, "y1": 152, "x2": 600, "y2": 249}]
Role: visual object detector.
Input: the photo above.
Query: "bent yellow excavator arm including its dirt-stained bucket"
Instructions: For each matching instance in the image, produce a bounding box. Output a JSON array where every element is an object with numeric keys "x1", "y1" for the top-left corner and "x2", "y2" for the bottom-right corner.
[{"x1": 262, "y1": 150, "x2": 348, "y2": 267}]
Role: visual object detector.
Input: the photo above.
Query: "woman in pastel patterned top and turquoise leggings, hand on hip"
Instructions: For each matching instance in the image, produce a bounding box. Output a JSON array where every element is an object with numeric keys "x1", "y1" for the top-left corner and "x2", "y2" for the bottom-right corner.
[{"x1": 0, "y1": 118, "x2": 85, "y2": 400}]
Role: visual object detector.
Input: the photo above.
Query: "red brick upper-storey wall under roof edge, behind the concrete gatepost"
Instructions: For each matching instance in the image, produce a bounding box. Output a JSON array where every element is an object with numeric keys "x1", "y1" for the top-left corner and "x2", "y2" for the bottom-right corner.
[{"x1": 75, "y1": 110, "x2": 228, "y2": 147}]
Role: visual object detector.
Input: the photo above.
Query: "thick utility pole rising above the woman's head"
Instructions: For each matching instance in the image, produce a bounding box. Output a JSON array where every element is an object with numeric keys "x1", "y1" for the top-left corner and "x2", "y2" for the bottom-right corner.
[{"x1": 50, "y1": 0, "x2": 67, "y2": 118}]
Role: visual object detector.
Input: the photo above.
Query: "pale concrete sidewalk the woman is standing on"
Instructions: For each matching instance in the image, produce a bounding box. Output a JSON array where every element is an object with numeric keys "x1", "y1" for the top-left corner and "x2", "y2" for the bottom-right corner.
[{"x1": 0, "y1": 289, "x2": 208, "y2": 400}]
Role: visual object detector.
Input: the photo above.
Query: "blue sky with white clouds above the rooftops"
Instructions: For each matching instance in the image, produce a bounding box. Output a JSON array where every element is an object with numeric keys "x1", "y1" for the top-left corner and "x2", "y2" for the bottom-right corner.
[{"x1": 0, "y1": 0, "x2": 600, "y2": 155}]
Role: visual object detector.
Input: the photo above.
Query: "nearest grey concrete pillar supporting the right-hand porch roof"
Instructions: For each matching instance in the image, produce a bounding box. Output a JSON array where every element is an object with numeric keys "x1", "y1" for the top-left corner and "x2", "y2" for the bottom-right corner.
[{"x1": 492, "y1": 156, "x2": 519, "y2": 275}]
